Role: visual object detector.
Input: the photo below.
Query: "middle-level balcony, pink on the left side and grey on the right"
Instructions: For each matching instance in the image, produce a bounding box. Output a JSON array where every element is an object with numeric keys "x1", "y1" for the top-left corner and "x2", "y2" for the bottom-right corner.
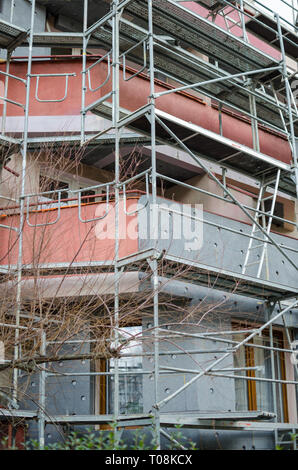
[{"x1": 0, "y1": 191, "x2": 298, "y2": 298}]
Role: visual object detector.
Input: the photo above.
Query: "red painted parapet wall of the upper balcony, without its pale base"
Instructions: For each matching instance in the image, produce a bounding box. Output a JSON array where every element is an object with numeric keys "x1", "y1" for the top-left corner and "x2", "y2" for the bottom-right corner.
[{"x1": 0, "y1": 59, "x2": 291, "y2": 163}]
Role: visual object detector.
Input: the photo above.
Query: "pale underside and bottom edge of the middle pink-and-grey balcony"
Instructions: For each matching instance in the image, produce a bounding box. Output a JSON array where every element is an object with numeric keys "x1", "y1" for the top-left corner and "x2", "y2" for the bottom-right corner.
[{"x1": 3, "y1": 249, "x2": 298, "y2": 300}]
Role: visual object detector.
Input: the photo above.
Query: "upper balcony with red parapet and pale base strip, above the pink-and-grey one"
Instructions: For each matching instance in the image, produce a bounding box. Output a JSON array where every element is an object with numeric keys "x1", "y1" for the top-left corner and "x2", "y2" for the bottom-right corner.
[{"x1": 0, "y1": 57, "x2": 291, "y2": 164}]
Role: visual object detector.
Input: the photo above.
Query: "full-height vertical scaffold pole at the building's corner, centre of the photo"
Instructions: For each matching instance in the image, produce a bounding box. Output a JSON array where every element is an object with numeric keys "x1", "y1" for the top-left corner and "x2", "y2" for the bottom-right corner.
[{"x1": 148, "y1": 0, "x2": 160, "y2": 449}]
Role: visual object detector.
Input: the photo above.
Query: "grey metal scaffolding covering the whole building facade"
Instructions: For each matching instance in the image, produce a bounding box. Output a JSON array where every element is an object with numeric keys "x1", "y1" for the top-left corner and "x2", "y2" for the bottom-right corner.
[{"x1": 0, "y1": 0, "x2": 298, "y2": 448}]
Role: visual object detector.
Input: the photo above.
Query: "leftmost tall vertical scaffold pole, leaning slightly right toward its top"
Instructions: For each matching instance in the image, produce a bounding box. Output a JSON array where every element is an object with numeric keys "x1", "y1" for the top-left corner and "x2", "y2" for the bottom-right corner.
[{"x1": 13, "y1": 0, "x2": 35, "y2": 403}]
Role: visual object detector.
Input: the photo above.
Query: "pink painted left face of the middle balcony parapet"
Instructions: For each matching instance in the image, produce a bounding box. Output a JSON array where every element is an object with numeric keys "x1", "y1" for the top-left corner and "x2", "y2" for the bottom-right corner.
[{"x1": 0, "y1": 198, "x2": 138, "y2": 265}]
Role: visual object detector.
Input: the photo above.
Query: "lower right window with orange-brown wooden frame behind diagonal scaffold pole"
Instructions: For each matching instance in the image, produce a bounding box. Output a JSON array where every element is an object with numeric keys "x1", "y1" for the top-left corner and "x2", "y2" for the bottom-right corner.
[{"x1": 234, "y1": 324, "x2": 288, "y2": 422}]
